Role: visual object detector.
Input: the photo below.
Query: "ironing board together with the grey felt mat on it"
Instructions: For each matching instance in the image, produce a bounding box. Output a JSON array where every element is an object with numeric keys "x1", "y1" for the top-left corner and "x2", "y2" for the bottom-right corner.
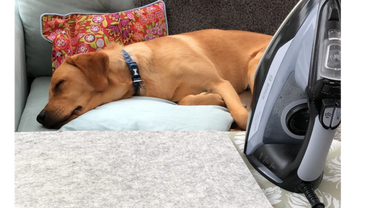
[{"x1": 12, "y1": 124, "x2": 344, "y2": 208}]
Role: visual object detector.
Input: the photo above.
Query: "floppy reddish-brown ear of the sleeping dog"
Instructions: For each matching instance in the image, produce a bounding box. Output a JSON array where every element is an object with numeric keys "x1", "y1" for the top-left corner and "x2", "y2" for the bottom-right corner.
[{"x1": 66, "y1": 52, "x2": 109, "y2": 91}]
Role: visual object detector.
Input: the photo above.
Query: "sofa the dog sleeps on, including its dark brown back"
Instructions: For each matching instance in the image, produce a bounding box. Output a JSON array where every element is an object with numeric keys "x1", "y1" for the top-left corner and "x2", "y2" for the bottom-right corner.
[{"x1": 12, "y1": 0, "x2": 297, "y2": 132}]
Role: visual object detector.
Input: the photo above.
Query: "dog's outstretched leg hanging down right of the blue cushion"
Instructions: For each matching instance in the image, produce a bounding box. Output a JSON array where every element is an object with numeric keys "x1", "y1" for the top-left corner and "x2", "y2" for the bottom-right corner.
[{"x1": 212, "y1": 80, "x2": 248, "y2": 130}]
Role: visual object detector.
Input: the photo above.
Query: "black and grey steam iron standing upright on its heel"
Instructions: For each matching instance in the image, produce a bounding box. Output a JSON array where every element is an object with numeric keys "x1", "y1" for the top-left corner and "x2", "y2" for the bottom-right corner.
[{"x1": 244, "y1": 0, "x2": 344, "y2": 207}]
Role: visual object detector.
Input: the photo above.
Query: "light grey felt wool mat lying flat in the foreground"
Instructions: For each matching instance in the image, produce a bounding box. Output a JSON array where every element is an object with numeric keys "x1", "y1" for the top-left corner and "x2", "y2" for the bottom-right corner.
[{"x1": 12, "y1": 131, "x2": 272, "y2": 208}]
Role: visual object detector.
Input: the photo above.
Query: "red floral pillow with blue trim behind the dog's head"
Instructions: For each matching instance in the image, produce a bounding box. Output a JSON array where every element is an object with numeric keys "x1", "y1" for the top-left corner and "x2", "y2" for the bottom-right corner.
[{"x1": 40, "y1": 1, "x2": 168, "y2": 71}]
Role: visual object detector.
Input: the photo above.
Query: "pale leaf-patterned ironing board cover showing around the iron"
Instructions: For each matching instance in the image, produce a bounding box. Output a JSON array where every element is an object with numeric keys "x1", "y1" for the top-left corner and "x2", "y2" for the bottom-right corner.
[{"x1": 228, "y1": 123, "x2": 344, "y2": 208}]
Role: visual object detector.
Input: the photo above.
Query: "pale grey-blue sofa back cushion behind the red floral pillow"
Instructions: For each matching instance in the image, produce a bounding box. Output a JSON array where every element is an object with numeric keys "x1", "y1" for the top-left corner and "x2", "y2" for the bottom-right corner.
[{"x1": 17, "y1": 0, "x2": 134, "y2": 78}]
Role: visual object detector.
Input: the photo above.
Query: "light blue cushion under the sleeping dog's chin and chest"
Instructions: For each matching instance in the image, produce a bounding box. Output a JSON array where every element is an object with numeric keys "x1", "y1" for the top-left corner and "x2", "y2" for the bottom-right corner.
[{"x1": 60, "y1": 96, "x2": 234, "y2": 131}]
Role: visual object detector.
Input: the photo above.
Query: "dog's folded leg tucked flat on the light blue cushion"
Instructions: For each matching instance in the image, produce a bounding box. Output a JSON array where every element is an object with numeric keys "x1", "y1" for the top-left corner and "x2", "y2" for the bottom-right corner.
[{"x1": 178, "y1": 92, "x2": 225, "y2": 107}]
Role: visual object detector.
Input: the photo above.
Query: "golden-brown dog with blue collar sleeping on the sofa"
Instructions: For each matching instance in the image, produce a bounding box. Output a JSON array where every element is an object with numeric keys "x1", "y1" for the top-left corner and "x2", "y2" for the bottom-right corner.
[{"x1": 37, "y1": 29, "x2": 272, "y2": 129}]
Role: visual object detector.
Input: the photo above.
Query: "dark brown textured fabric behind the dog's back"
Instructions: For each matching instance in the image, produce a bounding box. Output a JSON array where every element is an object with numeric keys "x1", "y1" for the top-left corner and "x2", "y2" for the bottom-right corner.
[{"x1": 133, "y1": 0, "x2": 299, "y2": 35}]
